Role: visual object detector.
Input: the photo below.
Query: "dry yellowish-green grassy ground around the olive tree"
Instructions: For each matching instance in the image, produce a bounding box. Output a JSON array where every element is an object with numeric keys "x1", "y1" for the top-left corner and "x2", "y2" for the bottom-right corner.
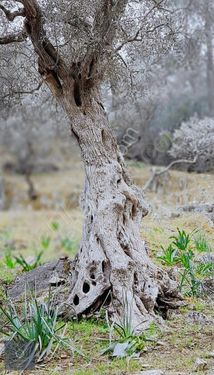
[{"x1": 0, "y1": 160, "x2": 214, "y2": 375}]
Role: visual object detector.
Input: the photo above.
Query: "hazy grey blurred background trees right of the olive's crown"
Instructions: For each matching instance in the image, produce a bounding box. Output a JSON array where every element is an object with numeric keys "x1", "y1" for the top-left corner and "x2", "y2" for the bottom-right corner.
[{"x1": 110, "y1": 0, "x2": 214, "y2": 167}]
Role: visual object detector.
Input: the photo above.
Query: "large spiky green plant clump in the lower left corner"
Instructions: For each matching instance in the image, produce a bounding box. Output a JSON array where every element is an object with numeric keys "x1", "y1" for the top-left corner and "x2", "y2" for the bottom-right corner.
[{"x1": 0, "y1": 293, "x2": 80, "y2": 368}]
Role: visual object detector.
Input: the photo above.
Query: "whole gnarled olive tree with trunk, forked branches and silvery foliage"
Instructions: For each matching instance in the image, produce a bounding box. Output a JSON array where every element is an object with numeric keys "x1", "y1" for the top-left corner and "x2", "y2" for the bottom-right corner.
[{"x1": 0, "y1": 0, "x2": 182, "y2": 330}]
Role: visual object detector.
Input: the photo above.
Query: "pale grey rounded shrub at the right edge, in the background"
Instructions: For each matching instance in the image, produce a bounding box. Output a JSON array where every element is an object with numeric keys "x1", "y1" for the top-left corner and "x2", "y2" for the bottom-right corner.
[{"x1": 170, "y1": 117, "x2": 214, "y2": 172}]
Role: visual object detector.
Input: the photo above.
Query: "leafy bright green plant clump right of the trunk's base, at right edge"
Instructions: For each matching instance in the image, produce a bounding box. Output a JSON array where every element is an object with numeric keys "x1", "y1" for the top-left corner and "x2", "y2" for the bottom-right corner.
[{"x1": 158, "y1": 228, "x2": 214, "y2": 296}]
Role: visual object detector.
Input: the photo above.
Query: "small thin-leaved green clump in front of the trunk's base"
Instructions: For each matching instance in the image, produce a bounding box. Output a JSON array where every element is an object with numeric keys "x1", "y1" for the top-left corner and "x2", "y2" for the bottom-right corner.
[{"x1": 102, "y1": 294, "x2": 160, "y2": 358}]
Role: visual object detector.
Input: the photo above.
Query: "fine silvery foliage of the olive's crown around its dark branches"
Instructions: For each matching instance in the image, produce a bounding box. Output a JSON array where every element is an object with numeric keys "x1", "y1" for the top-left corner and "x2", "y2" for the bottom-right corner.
[{"x1": 0, "y1": 0, "x2": 182, "y2": 106}]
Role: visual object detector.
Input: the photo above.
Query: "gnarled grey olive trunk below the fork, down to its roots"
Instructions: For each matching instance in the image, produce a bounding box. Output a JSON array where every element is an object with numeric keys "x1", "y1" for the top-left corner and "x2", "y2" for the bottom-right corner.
[{"x1": 57, "y1": 92, "x2": 177, "y2": 330}]
